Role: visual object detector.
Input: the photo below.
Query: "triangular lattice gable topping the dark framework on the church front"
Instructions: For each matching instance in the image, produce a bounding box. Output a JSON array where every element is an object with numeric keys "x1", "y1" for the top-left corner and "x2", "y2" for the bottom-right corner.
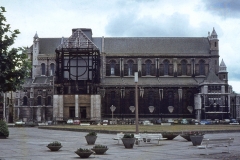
[{"x1": 57, "y1": 29, "x2": 98, "y2": 50}]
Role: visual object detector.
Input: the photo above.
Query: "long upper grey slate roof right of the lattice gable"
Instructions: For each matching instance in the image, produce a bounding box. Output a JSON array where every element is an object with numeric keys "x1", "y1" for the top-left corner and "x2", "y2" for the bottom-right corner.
[{"x1": 104, "y1": 37, "x2": 210, "y2": 55}]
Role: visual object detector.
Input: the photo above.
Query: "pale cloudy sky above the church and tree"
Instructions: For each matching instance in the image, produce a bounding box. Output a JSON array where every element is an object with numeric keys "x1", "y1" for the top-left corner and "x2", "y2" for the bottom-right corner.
[{"x1": 0, "y1": 0, "x2": 240, "y2": 93}]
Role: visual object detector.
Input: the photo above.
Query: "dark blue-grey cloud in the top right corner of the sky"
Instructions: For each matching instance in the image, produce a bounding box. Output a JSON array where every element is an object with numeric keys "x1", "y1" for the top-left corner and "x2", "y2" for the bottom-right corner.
[{"x1": 202, "y1": 0, "x2": 240, "y2": 18}]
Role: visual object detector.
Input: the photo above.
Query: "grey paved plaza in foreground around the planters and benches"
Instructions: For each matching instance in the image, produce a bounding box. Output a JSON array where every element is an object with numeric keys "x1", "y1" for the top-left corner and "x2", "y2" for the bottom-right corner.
[{"x1": 0, "y1": 127, "x2": 240, "y2": 160}]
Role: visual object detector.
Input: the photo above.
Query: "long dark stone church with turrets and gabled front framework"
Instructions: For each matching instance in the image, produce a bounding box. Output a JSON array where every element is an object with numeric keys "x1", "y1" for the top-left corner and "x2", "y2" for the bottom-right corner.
[{"x1": 1, "y1": 28, "x2": 240, "y2": 122}]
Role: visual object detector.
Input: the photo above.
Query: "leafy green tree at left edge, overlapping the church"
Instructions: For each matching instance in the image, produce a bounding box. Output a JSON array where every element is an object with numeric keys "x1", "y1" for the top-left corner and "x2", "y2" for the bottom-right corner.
[{"x1": 0, "y1": 7, "x2": 31, "y2": 92}]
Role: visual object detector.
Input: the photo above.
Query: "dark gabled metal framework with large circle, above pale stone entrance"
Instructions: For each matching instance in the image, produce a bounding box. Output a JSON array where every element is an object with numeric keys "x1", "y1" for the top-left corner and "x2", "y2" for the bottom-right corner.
[{"x1": 55, "y1": 29, "x2": 100, "y2": 94}]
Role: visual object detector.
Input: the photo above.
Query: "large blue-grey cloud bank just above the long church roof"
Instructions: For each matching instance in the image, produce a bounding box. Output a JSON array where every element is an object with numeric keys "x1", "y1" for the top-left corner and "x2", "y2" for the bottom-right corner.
[{"x1": 105, "y1": 10, "x2": 221, "y2": 37}]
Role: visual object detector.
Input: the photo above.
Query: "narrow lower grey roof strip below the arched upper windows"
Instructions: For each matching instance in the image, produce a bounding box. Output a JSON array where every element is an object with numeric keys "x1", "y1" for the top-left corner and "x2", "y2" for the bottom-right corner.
[{"x1": 101, "y1": 77, "x2": 199, "y2": 87}]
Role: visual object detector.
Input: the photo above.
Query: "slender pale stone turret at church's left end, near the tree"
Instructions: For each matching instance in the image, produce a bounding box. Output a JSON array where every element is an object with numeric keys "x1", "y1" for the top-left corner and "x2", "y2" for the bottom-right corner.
[{"x1": 32, "y1": 33, "x2": 39, "y2": 78}]
